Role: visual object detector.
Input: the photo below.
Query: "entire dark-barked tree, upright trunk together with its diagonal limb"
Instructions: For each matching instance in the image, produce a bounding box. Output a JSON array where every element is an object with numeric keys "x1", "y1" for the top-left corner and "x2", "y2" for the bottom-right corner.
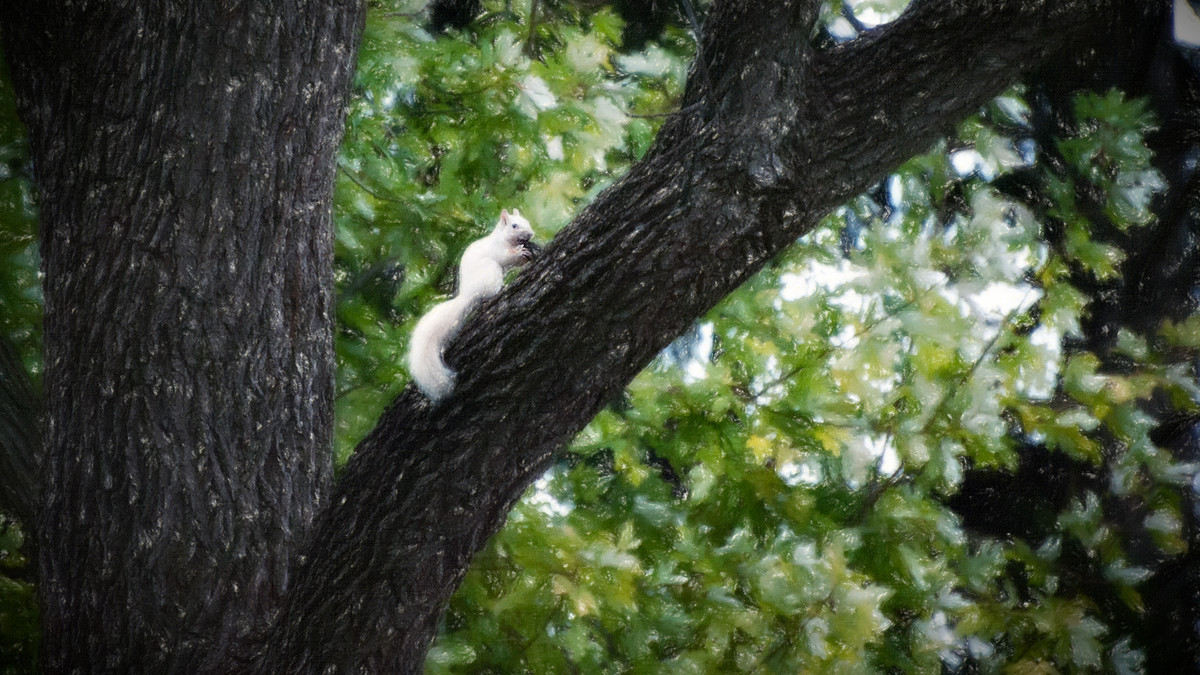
[{"x1": 0, "y1": 0, "x2": 1190, "y2": 673}]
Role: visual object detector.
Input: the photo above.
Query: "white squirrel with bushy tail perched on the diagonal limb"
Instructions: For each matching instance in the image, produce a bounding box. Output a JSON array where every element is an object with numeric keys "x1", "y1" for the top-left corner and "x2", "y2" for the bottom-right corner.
[{"x1": 408, "y1": 209, "x2": 536, "y2": 402}]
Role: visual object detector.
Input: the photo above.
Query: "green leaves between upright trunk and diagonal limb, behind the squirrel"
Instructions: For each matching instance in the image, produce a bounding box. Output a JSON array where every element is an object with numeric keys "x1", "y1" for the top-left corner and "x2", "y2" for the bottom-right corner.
[{"x1": 336, "y1": 2, "x2": 690, "y2": 461}]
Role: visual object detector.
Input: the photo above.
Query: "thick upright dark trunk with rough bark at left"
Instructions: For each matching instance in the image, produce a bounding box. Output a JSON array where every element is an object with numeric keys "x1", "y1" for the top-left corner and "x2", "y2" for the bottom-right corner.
[{"x1": 0, "y1": 0, "x2": 361, "y2": 673}]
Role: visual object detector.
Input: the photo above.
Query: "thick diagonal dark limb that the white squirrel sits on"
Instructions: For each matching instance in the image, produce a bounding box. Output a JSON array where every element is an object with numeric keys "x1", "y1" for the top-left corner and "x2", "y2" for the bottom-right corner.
[{"x1": 260, "y1": 0, "x2": 1134, "y2": 671}]
